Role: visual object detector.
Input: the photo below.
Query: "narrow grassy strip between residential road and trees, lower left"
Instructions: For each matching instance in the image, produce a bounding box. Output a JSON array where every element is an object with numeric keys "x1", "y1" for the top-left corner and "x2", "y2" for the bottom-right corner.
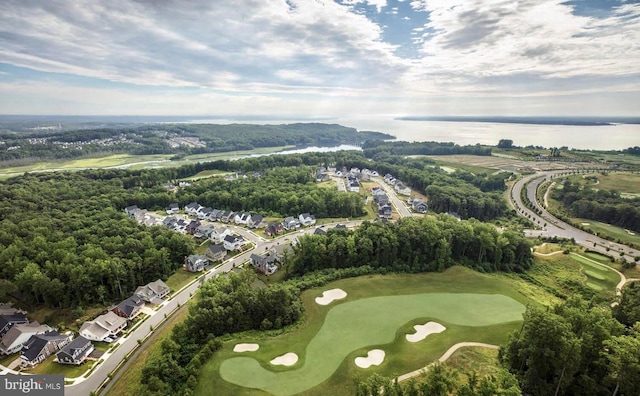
[{"x1": 106, "y1": 309, "x2": 189, "y2": 396}]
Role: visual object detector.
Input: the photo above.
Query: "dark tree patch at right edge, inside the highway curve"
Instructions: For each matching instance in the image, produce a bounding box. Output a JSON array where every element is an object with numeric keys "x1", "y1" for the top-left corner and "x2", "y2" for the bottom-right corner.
[{"x1": 551, "y1": 180, "x2": 640, "y2": 232}]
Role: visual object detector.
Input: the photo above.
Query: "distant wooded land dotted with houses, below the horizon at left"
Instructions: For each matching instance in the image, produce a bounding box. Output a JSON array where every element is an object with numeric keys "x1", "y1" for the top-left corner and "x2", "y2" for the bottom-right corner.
[{"x1": 0, "y1": 123, "x2": 394, "y2": 161}]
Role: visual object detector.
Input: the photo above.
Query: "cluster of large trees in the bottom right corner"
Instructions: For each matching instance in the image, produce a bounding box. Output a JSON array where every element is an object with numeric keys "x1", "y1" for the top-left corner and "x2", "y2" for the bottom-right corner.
[{"x1": 500, "y1": 297, "x2": 640, "y2": 396}]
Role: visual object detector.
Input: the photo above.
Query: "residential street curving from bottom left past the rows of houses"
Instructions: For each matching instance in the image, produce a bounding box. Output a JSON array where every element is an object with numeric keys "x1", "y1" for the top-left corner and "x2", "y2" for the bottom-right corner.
[{"x1": 65, "y1": 220, "x2": 362, "y2": 396}]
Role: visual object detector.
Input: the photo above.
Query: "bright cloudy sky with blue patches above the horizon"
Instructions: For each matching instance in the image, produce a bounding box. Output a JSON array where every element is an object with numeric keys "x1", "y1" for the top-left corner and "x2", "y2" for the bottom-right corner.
[{"x1": 0, "y1": 0, "x2": 640, "y2": 118}]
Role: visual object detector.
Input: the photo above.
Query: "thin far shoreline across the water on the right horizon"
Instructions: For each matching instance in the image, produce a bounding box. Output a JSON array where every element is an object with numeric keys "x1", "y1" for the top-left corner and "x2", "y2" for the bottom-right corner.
[{"x1": 395, "y1": 116, "x2": 640, "y2": 126}]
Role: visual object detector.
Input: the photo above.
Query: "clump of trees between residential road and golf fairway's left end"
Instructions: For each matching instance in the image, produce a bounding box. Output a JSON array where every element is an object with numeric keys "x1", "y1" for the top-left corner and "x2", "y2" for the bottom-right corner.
[{"x1": 139, "y1": 271, "x2": 302, "y2": 396}]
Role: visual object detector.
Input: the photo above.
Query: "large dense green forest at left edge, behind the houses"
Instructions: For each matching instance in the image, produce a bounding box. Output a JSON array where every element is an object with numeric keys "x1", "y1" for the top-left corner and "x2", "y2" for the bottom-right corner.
[{"x1": 0, "y1": 173, "x2": 194, "y2": 308}]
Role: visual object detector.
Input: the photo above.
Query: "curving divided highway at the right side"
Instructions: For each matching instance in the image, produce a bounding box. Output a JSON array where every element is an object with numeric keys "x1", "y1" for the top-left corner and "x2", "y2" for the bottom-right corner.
[{"x1": 511, "y1": 171, "x2": 640, "y2": 262}]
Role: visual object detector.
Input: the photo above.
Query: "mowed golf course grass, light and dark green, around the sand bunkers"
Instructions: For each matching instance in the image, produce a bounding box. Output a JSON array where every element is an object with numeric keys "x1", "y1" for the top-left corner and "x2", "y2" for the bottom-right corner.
[{"x1": 196, "y1": 267, "x2": 536, "y2": 395}]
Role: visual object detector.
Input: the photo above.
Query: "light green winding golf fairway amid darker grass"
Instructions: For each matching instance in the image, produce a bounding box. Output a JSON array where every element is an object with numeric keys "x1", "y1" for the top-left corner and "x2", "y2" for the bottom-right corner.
[{"x1": 220, "y1": 293, "x2": 525, "y2": 395}]
